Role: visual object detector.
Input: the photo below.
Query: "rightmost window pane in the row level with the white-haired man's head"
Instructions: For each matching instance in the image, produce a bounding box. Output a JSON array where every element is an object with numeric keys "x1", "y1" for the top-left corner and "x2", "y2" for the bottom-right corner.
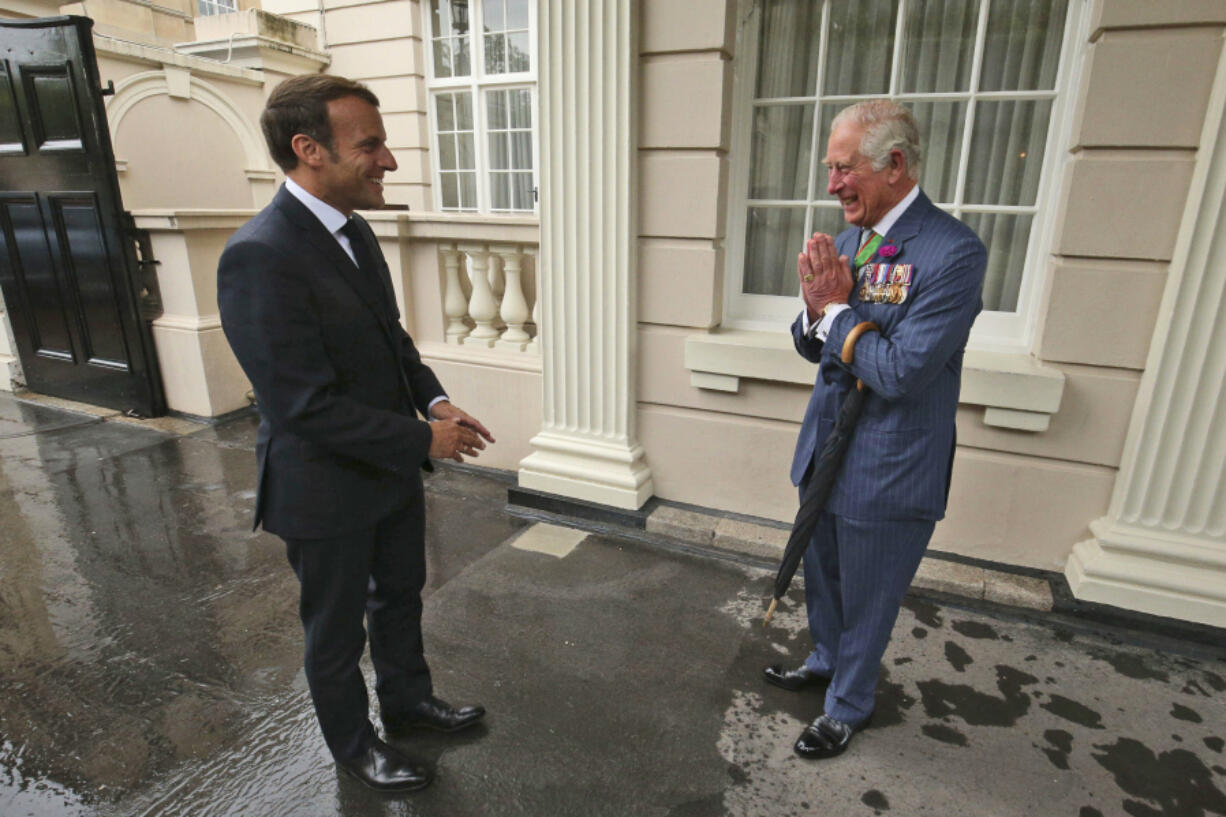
[{"x1": 962, "y1": 99, "x2": 1052, "y2": 206}]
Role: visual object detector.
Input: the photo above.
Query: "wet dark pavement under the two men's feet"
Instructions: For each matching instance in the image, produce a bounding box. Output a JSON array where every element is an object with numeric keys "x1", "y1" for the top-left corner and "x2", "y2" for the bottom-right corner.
[{"x1": 0, "y1": 396, "x2": 1226, "y2": 817}]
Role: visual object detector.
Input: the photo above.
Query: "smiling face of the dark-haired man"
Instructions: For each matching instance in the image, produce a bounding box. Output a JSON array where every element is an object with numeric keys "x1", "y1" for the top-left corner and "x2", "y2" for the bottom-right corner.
[{"x1": 318, "y1": 97, "x2": 396, "y2": 216}]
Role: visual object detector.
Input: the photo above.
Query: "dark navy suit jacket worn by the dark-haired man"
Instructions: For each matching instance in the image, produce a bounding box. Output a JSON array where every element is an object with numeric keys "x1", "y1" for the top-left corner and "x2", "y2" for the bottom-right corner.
[{"x1": 217, "y1": 186, "x2": 443, "y2": 539}]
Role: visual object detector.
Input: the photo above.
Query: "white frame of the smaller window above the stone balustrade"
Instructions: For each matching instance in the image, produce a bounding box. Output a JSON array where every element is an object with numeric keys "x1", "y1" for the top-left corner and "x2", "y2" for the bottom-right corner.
[{"x1": 421, "y1": 0, "x2": 541, "y2": 216}]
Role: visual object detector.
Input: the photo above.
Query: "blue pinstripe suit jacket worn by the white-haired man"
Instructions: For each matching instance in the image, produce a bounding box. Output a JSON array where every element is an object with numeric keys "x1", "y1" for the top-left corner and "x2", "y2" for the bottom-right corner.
[{"x1": 792, "y1": 191, "x2": 987, "y2": 520}]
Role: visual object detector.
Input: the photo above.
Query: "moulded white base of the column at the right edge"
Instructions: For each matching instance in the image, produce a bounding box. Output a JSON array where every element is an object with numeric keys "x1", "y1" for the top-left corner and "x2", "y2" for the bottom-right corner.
[{"x1": 1064, "y1": 518, "x2": 1226, "y2": 627}]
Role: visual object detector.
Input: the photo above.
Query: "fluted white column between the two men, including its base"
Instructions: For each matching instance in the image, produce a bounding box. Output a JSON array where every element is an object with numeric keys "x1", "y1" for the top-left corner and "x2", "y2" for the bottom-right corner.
[{"x1": 519, "y1": 0, "x2": 652, "y2": 509}]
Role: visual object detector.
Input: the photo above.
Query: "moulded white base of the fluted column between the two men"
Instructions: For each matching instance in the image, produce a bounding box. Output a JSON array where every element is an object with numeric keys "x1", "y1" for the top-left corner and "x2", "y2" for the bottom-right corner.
[{"x1": 519, "y1": 432, "x2": 655, "y2": 510}]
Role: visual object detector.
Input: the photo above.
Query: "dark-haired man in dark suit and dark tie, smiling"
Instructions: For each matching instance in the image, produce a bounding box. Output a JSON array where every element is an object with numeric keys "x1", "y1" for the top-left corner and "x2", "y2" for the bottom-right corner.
[{"x1": 217, "y1": 75, "x2": 493, "y2": 790}]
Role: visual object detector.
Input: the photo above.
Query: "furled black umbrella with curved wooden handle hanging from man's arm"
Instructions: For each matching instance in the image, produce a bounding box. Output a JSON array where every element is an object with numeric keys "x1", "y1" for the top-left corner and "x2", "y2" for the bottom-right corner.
[{"x1": 763, "y1": 320, "x2": 880, "y2": 627}]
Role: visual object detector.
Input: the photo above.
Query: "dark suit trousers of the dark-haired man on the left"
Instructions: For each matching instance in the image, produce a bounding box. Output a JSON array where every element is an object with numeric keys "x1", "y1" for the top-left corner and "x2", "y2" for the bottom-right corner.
[{"x1": 286, "y1": 477, "x2": 433, "y2": 759}]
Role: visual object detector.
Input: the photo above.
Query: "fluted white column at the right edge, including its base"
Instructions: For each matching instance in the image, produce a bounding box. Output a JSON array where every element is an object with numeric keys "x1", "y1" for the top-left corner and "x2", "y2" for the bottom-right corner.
[{"x1": 1065, "y1": 53, "x2": 1226, "y2": 627}]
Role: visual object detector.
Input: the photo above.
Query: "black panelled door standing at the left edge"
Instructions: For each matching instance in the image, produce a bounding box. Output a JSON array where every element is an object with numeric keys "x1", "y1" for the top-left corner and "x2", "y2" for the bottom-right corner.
[{"x1": 0, "y1": 17, "x2": 166, "y2": 416}]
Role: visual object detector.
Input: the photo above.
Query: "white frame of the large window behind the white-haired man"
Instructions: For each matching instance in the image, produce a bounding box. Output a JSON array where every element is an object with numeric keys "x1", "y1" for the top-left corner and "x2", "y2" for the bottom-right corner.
[{"x1": 722, "y1": 0, "x2": 1089, "y2": 352}]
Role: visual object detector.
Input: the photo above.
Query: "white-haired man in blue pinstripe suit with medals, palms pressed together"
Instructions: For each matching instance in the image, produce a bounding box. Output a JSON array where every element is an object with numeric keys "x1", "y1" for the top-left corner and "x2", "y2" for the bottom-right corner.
[{"x1": 765, "y1": 101, "x2": 987, "y2": 758}]
